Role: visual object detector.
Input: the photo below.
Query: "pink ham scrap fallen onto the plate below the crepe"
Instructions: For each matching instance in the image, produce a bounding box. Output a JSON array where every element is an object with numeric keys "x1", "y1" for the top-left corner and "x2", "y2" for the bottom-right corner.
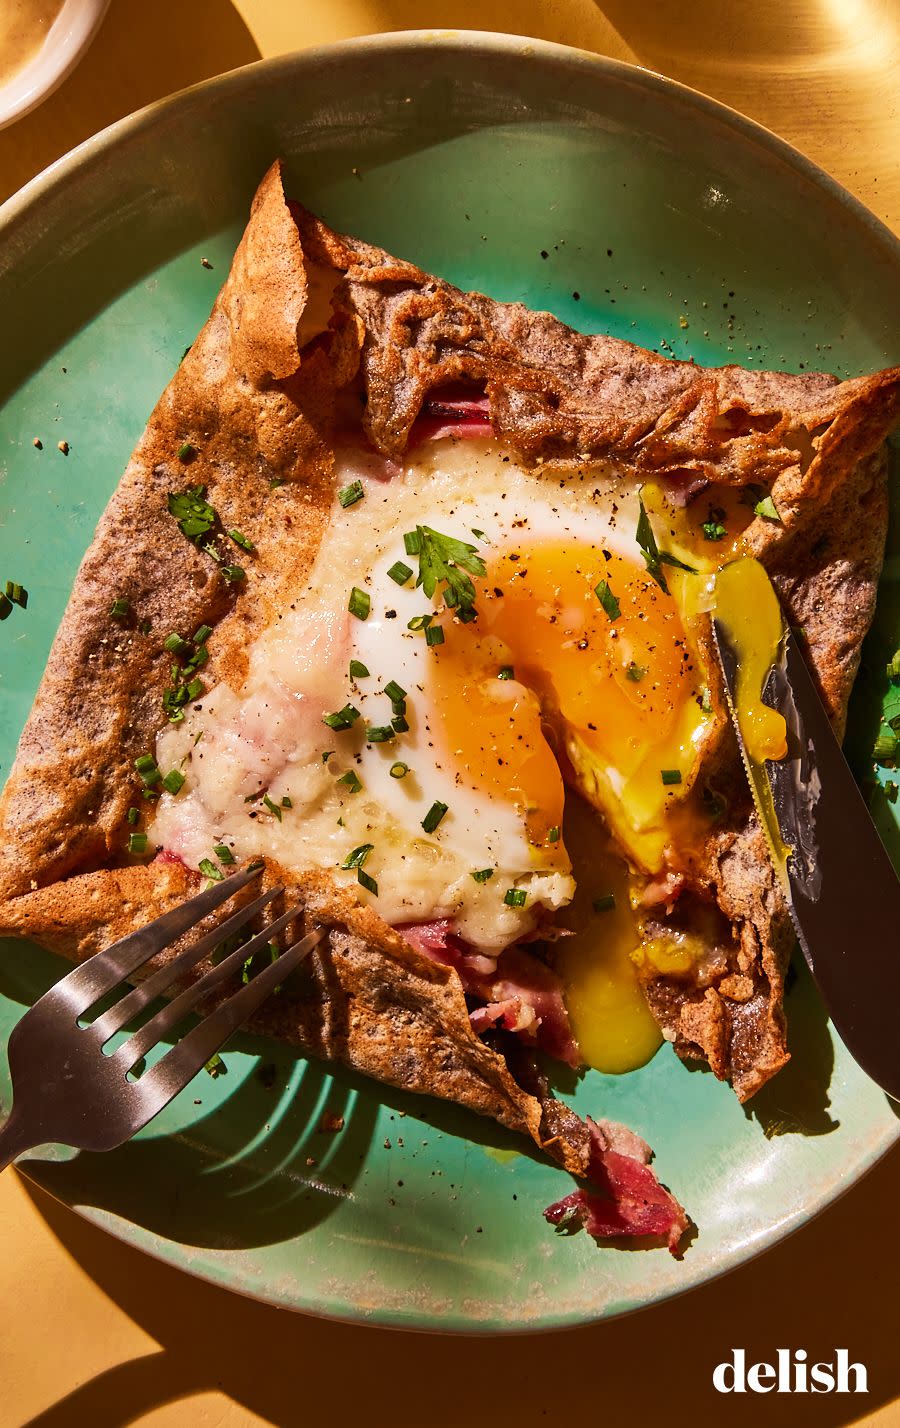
[{"x1": 544, "y1": 1115, "x2": 690, "y2": 1255}]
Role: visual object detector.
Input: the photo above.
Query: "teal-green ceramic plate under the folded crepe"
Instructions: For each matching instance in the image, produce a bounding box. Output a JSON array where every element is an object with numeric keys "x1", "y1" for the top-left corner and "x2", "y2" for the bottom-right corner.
[{"x1": 0, "y1": 33, "x2": 900, "y2": 1331}]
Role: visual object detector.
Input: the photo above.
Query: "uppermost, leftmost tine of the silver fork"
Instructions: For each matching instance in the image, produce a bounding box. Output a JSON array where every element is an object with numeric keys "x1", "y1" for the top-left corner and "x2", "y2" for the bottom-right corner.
[{"x1": 54, "y1": 864, "x2": 263, "y2": 1017}]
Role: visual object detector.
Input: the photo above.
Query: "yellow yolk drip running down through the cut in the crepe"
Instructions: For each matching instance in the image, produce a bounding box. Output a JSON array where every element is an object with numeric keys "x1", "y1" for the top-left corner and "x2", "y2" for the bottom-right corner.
[{"x1": 556, "y1": 795, "x2": 663, "y2": 1072}]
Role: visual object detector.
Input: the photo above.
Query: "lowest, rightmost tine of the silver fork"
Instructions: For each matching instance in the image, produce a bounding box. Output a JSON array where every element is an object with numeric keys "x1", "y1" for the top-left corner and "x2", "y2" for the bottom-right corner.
[{"x1": 134, "y1": 925, "x2": 326, "y2": 1115}]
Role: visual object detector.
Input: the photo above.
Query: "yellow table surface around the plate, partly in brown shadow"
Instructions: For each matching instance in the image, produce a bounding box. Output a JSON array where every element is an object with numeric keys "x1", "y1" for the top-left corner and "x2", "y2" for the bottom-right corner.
[{"x1": 0, "y1": 0, "x2": 900, "y2": 1428}]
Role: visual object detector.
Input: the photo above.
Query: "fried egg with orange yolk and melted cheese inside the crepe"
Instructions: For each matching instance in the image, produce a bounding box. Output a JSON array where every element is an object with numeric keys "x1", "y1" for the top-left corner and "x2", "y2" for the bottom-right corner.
[{"x1": 150, "y1": 437, "x2": 711, "y2": 952}]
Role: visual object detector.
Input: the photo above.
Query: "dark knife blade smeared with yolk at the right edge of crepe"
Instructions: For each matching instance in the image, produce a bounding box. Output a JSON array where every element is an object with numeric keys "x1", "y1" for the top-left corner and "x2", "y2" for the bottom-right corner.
[{"x1": 713, "y1": 565, "x2": 900, "y2": 1100}]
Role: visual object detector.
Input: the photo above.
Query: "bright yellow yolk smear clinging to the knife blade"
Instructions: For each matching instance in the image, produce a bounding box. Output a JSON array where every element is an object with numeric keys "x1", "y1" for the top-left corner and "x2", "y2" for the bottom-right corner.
[{"x1": 716, "y1": 558, "x2": 787, "y2": 763}]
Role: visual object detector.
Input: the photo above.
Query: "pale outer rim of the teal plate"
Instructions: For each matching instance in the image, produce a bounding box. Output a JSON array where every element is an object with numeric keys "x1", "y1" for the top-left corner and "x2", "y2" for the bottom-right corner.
[{"x1": 0, "y1": 29, "x2": 900, "y2": 1337}]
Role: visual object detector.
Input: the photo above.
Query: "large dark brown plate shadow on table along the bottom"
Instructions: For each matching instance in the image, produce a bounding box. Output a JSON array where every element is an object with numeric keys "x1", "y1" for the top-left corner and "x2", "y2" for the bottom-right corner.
[{"x1": 17, "y1": 1136, "x2": 900, "y2": 1428}]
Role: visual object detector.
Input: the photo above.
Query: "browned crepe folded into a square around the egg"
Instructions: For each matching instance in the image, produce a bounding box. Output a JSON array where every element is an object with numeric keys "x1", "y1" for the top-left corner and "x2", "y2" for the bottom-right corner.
[{"x1": 0, "y1": 166, "x2": 900, "y2": 1172}]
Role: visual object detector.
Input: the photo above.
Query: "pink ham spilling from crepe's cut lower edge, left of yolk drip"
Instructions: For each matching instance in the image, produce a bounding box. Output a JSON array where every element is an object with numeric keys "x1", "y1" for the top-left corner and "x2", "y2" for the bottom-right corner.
[{"x1": 397, "y1": 918, "x2": 583, "y2": 1067}]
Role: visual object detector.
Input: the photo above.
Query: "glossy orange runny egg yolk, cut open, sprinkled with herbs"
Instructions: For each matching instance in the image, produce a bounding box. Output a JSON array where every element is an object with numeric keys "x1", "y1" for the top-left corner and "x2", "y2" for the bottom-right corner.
[{"x1": 429, "y1": 541, "x2": 691, "y2": 861}]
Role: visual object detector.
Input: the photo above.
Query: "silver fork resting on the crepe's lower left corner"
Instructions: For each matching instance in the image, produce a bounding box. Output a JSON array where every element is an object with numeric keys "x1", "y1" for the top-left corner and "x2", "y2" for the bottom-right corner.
[{"x1": 0, "y1": 865, "x2": 324, "y2": 1170}]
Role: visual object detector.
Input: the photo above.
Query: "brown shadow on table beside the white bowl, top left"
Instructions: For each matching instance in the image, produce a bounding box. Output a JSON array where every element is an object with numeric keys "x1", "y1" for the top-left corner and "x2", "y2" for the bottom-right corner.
[{"x1": 0, "y1": 0, "x2": 260, "y2": 208}]
